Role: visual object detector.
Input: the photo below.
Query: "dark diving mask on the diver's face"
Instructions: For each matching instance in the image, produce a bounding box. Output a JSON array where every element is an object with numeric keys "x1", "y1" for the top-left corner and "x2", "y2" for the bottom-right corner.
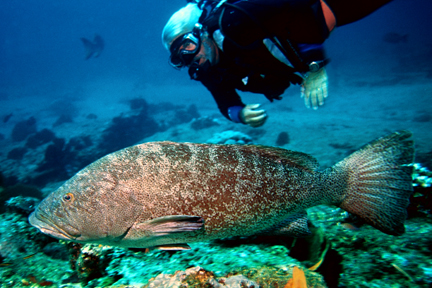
[{"x1": 169, "y1": 24, "x2": 202, "y2": 69}]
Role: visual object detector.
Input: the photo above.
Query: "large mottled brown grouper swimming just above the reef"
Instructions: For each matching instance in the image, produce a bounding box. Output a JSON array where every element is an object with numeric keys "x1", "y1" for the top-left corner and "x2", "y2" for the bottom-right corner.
[{"x1": 29, "y1": 131, "x2": 414, "y2": 249}]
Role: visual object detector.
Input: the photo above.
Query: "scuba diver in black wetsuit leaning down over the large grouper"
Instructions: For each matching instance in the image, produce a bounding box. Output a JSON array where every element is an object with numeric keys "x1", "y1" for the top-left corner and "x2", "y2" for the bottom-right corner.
[{"x1": 162, "y1": 0, "x2": 392, "y2": 127}]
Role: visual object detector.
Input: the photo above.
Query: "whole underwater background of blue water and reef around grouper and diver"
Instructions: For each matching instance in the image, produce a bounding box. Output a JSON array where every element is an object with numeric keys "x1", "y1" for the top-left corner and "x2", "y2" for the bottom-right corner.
[{"x1": 0, "y1": 0, "x2": 432, "y2": 287}]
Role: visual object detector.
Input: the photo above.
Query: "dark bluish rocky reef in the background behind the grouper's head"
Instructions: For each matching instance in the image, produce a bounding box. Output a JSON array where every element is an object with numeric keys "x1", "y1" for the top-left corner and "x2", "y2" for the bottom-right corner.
[{"x1": 0, "y1": 97, "x2": 202, "y2": 188}]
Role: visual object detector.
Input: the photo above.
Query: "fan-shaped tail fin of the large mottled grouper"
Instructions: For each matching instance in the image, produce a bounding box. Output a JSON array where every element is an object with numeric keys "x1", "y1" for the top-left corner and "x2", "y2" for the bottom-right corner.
[{"x1": 333, "y1": 131, "x2": 414, "y2": 235}]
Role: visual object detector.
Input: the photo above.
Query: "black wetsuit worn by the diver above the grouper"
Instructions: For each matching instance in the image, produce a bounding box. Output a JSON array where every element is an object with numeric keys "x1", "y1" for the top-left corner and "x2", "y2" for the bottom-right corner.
[{"x1": 189, "y1": 0, "x2": 392, "y2": 122}]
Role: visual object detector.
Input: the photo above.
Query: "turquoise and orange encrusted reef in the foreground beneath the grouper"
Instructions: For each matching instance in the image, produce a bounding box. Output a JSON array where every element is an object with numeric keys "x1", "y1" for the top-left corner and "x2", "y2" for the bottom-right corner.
[{"x1": 0, "y1": 199, "x2": 432, "y2": 288}]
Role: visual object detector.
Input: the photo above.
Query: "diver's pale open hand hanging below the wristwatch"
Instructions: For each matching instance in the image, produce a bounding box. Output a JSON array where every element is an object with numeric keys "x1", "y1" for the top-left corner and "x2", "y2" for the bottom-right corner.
[{"x1": 301, "y1": 68, "x2": 328, "y2": 110}]
